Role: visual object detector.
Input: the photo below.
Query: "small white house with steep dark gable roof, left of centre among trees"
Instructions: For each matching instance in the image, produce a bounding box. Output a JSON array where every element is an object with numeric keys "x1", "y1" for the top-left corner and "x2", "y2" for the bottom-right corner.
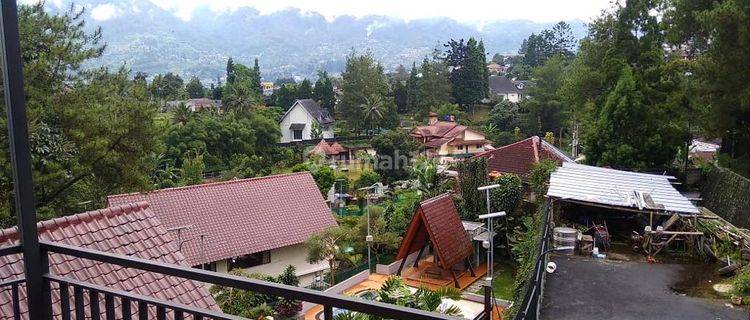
[{"x1": 279, "y1": 99, "x2": 333, "y2": 142}]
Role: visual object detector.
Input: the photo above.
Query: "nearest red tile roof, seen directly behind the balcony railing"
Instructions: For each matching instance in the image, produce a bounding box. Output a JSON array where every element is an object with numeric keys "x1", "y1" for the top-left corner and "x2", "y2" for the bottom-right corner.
[{"x1": 0, "y1": 202, "x2": 220, "y2": 319}]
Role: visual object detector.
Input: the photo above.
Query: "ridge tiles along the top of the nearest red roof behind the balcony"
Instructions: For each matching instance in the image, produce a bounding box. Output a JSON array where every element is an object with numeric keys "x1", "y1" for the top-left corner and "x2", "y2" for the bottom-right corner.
[{"x1": 0, "y1": 201, "x2": 150, "y2": 239}]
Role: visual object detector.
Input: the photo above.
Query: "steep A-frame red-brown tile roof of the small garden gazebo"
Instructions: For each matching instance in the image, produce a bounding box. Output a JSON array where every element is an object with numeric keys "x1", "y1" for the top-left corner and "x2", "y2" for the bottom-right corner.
[{"x1": 396, "y1": 193, "x2": 474, "y2": 269}]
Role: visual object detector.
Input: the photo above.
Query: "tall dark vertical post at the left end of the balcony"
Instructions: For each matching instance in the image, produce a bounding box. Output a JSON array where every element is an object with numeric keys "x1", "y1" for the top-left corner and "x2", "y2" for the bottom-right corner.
[{"x1": 0, "y1": 0, "x2": 51, "y2": 319}]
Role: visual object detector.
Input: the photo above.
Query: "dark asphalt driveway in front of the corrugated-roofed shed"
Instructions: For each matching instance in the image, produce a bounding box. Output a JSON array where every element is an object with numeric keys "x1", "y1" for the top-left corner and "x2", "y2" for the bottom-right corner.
[{"x1": 541, "y1": 256, "x2": 750, "y2": 320}]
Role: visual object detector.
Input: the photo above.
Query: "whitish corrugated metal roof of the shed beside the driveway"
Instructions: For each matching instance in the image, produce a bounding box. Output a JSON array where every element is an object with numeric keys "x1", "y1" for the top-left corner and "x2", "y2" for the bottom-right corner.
[{"x1": 547, "y1": 162, "x2": 699, "y2": 214}]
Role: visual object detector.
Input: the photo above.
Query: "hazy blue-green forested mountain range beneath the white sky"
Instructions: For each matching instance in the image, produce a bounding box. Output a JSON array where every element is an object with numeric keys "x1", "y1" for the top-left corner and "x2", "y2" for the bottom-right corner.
[{"x1": 45, "y1": 0, "x2": 586, "y2": 81}]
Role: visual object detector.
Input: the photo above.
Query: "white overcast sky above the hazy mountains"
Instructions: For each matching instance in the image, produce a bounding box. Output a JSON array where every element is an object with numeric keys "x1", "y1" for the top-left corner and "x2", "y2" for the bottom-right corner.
[{"x1": 150, "y1": 0, "x2": 612, "y2": 24}]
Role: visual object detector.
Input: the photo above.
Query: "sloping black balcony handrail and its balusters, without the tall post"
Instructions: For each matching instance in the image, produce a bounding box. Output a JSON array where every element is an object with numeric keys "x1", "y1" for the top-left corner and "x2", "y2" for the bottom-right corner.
[{"x1": 0, "y1": 241, "x2": 458, "y2": 320}]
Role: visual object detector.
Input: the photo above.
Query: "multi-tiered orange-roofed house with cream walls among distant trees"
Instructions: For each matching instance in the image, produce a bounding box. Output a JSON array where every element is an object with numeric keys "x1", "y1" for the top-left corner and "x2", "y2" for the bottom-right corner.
[{"x1": 409, "y1": 113, "x2": 492, "y2": 163}]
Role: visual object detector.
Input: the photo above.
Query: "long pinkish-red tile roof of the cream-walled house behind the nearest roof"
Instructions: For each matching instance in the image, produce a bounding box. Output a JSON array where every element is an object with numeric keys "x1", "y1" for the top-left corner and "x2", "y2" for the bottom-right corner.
[{"x1": 107, "y1": 172, "x2": 336, "y2": 265}]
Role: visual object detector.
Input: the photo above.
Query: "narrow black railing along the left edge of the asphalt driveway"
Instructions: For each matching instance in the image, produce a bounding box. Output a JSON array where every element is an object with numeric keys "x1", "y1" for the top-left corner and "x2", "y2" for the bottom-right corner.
[{"x1": 514, "y1": 201, "x2": 551, "y2": 320}]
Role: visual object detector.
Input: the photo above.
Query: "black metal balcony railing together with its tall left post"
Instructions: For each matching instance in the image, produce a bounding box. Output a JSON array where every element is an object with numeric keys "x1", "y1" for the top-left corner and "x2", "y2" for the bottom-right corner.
[{"x1": 0, "y1": 0, "x2": 490, "y2": 320}]
